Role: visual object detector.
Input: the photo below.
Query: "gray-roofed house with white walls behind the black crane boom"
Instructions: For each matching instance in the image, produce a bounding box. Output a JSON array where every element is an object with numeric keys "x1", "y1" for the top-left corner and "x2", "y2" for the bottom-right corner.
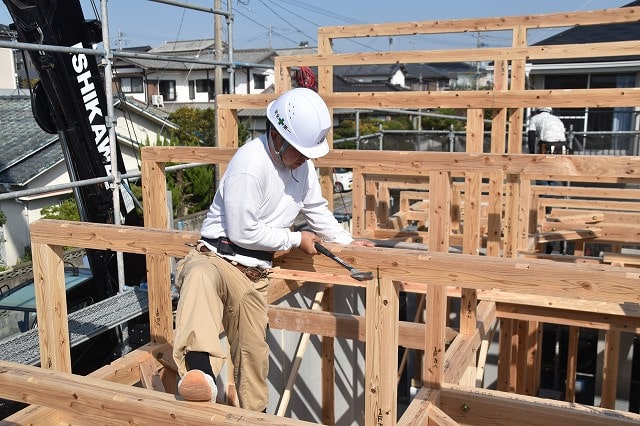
[{"x1": 0, "y1": 94, "x2": 176, "y2": 266}]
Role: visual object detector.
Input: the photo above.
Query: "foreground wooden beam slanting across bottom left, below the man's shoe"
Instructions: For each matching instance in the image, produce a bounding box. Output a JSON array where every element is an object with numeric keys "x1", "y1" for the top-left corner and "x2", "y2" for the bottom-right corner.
[{"x1": 0, "y1": 361, "x2": 311, "y2": 425}]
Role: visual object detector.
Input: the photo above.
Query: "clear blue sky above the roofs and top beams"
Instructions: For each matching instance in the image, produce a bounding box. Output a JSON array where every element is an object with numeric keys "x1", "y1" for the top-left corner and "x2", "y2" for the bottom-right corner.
[{"x1": 0, "y1": 0, "x2": 631, "y2": 52}]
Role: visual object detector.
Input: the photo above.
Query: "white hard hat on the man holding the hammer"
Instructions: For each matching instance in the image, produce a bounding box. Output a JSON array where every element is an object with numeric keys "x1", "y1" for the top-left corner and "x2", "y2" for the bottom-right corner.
[{"x1": 267, "y1": 87, "x2": 331, "y2": 158}]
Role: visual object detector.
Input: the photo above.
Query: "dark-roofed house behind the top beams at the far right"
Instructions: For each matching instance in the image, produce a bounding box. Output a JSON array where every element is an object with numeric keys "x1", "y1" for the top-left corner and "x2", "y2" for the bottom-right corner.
[{"x1": 527, "y1": 1, "x2": 640, "y2": 155}]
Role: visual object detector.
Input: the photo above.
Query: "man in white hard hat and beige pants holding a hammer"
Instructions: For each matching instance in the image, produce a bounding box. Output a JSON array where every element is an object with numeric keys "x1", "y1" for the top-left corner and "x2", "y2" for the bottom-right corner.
[{"x1": 173, "y1": 88, "x2": 373, "y2": 411}]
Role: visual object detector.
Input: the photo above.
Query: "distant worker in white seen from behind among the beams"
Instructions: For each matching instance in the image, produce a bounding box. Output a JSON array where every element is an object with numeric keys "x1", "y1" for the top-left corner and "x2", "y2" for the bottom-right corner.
[{"x1": 527, "y1": 107, "x2": 571, "y2": 154}]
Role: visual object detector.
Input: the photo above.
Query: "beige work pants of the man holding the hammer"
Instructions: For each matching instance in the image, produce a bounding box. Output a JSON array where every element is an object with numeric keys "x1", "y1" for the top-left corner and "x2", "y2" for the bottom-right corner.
[{"x1": 173, "y1": 250, "x2": 269, "y2": 411}]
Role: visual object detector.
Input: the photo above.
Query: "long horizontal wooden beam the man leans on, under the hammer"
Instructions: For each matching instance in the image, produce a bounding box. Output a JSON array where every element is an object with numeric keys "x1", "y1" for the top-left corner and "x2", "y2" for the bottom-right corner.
[{"x1": 31, "y1": 219, "x2": 640, "y2": 303}]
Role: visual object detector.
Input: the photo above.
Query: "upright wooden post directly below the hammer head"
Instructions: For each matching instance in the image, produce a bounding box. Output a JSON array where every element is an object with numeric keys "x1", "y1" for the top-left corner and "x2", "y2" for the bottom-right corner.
[{"x1": 365, "y1": 276, "x2": 400, "y2": 426}]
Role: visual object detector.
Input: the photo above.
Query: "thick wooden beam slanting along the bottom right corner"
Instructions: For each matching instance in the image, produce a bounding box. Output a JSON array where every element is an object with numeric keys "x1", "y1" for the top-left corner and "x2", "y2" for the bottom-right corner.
[{"x1": 440, "y1": 384, "x2": 640, "y2": 426}]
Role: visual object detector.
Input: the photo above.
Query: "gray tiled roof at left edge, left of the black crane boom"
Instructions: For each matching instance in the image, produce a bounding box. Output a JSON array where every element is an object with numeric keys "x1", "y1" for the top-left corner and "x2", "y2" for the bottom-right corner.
[{"x1": 0, "y1": 95, "x2": 64, "y2": 186}]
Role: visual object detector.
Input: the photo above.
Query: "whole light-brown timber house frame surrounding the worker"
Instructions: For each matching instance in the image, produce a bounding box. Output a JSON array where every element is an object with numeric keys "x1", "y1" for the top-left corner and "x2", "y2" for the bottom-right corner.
[{"x1": 0, "y1": 4, "x2": 640, "y2": 425}]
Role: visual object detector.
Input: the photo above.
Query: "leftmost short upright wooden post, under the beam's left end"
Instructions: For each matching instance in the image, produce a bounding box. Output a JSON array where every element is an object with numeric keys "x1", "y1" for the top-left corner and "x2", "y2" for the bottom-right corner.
[{"x1": 31, "y1": 241, "x2": 71, "y2": 373}]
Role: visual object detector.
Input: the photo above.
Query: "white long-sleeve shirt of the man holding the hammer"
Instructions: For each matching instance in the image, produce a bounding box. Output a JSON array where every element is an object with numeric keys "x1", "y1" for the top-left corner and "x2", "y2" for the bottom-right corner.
[{"x1": 200, "y1": 135, "x2": 353, "y2": 268}]
